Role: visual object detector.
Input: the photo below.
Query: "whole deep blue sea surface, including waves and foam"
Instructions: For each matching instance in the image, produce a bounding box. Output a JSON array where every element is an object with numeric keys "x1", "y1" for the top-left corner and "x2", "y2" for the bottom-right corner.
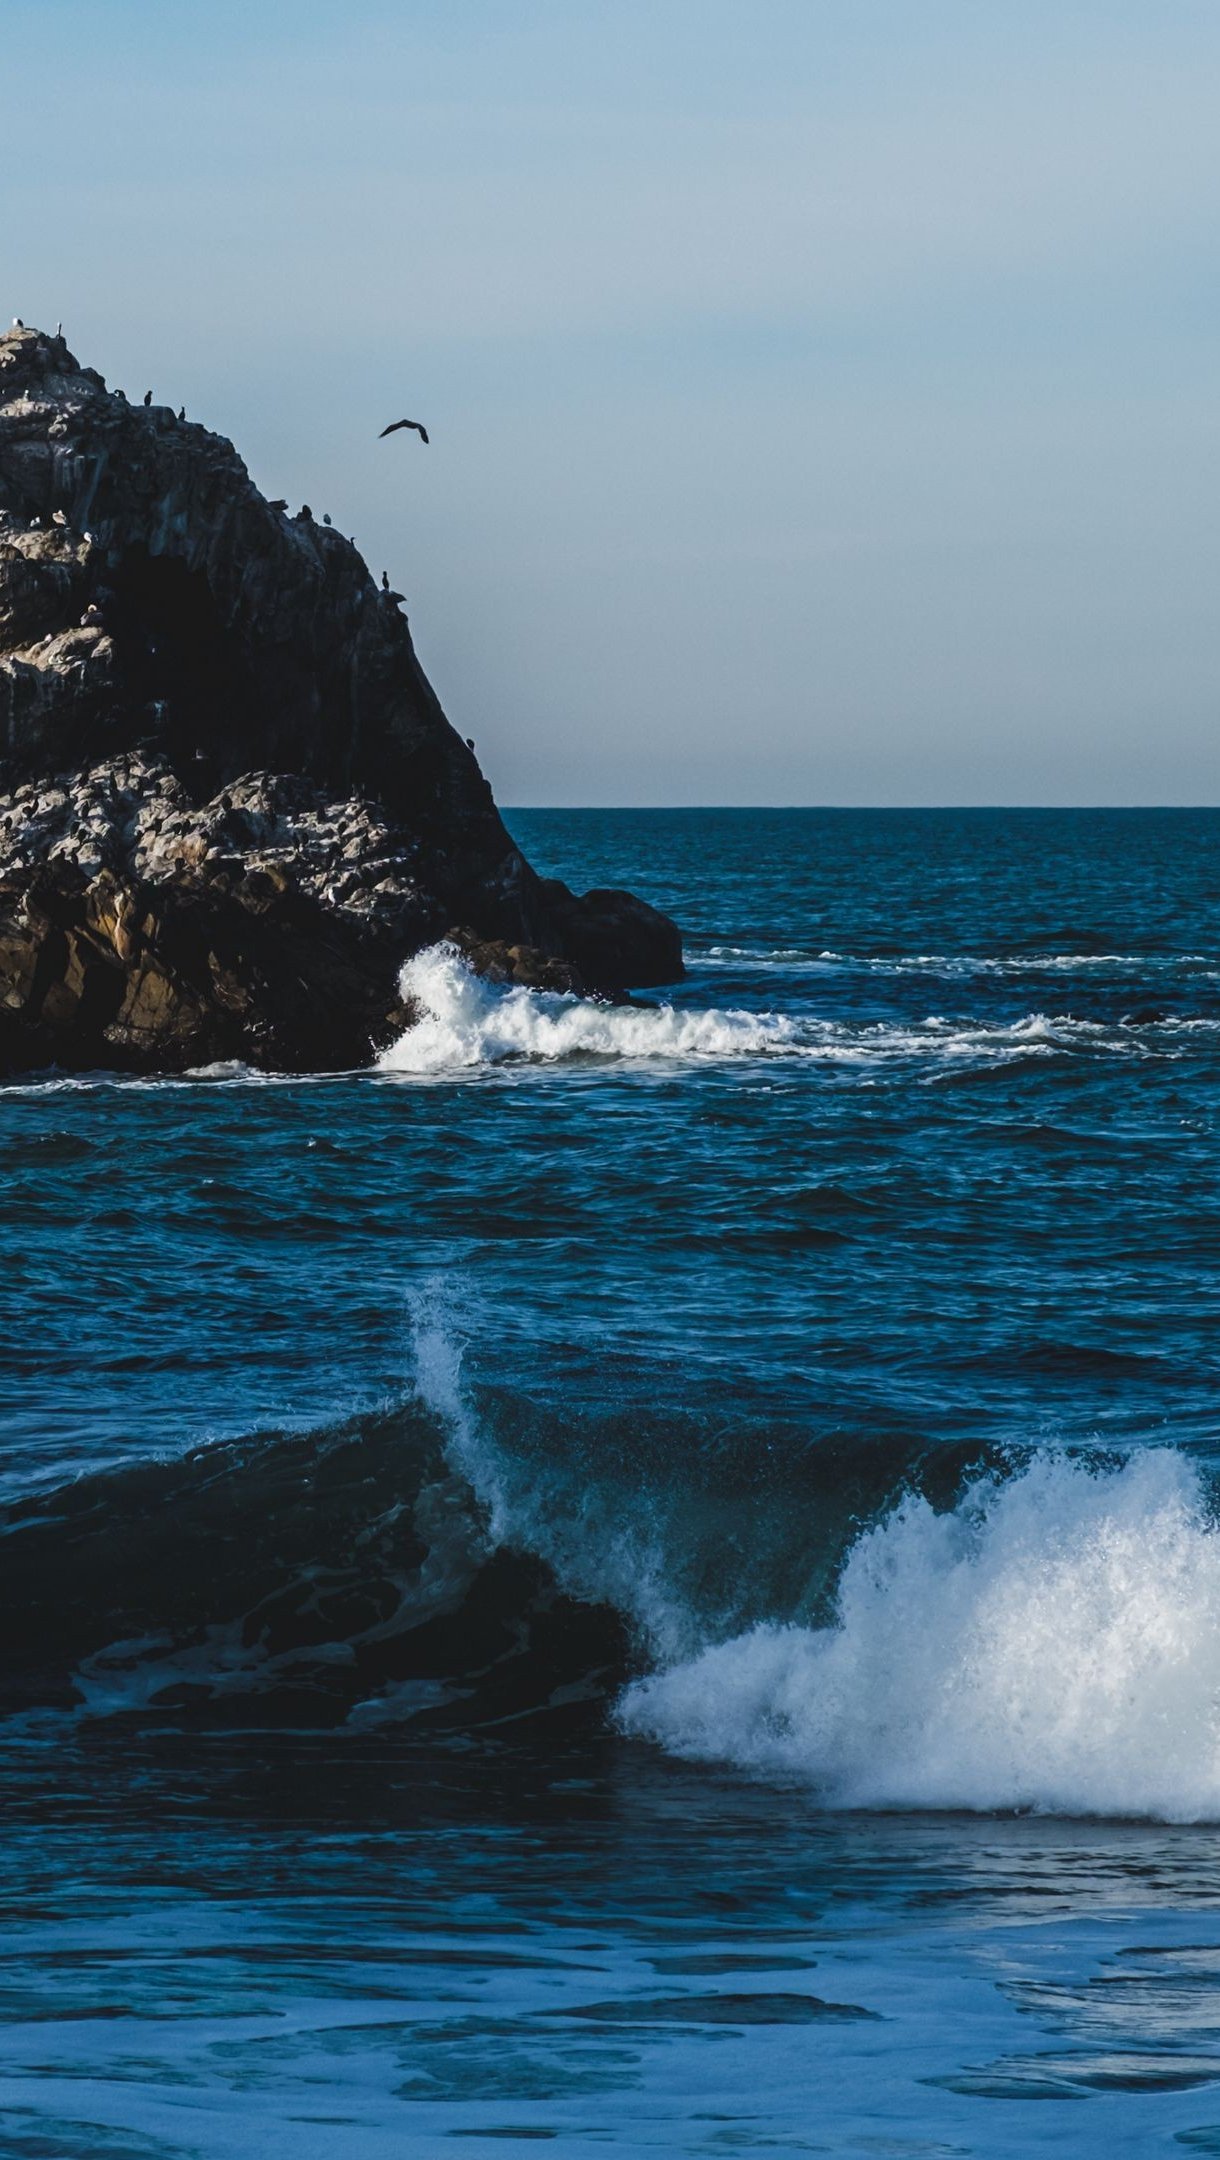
[{"x1": 0, "y1": 810, "x2": 1220, "y2": 2160}]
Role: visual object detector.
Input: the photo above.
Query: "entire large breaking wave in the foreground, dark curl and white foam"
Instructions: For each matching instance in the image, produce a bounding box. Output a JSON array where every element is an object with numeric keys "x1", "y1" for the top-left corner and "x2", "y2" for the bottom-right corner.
[{"x1": 0, "y1": 1309, "x2": 1220, "y2": 1821}]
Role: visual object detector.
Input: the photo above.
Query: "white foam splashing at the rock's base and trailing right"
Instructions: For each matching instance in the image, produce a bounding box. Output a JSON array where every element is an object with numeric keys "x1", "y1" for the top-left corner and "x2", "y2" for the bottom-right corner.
[{"x1": 378, "y1": 944, "x2": 1218, "y2": 1074}]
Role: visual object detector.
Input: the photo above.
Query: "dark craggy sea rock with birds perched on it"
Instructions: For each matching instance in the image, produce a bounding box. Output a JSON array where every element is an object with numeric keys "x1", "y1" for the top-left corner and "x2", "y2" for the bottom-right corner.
[{"x1": 0, "y1": 330, "x2": 682, "y2": 1069}]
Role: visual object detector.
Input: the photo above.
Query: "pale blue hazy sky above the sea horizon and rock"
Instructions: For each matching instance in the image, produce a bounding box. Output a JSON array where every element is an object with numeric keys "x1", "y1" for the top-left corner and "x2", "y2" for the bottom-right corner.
[{"x1": 0, "y1": 0, "x2": 1220, "y2": 806}]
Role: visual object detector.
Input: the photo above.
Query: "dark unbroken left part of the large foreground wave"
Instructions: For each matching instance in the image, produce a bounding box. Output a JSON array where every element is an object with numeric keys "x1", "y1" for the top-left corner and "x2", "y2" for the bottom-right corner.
[{"x1": 0, "y1": 1400, "x2": 628, "y2": 1734}]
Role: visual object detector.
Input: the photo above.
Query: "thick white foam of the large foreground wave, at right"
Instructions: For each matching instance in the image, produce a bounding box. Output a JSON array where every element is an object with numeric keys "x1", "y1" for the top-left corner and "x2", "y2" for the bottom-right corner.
[{"x1": 620, "y1": 1449, "x2": 1220, "y2": 1821}]
